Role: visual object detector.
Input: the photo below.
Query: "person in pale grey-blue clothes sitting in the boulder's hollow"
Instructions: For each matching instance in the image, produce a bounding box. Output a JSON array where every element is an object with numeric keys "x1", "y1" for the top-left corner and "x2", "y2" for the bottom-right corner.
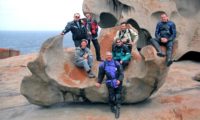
[{"x1": 75, "y1": 39, "x2": 95, "y2": 78}]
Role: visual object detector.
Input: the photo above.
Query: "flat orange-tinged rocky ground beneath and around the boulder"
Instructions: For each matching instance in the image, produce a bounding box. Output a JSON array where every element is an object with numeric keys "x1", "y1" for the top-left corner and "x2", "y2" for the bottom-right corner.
[{"x1": 0, "y1": 54, "x2": 200, "y2": 120}]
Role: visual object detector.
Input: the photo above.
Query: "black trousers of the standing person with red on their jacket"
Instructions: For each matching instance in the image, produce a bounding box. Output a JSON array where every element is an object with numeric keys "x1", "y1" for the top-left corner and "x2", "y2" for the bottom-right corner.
[{"x1": 87, "y1": 39, "x2": 101, "y2": 60}]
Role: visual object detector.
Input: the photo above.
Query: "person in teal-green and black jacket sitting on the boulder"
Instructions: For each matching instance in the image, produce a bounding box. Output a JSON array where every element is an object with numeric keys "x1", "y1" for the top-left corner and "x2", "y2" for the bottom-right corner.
[{"x1": 112, "y1": 38, "x2": 131, "y2": 69}]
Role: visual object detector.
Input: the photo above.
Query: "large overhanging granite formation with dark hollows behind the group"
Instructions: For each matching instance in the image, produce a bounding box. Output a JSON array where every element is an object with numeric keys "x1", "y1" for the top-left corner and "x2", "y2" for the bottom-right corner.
[{"x1": 83, "y1": 0, "x2": 200, "y2": 60}]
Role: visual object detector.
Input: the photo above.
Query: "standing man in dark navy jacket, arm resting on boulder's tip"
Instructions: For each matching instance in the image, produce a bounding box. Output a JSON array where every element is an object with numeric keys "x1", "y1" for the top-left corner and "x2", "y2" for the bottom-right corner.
[{"x1": 61, "y1": 13, "x2": 87, "y2": 47}]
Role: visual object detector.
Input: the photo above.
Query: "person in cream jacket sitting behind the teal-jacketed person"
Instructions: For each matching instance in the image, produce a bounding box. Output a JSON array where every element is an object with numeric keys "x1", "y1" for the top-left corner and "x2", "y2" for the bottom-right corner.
[{"x1": 114, "y1": 22, "x2": 138, "y2": 51}]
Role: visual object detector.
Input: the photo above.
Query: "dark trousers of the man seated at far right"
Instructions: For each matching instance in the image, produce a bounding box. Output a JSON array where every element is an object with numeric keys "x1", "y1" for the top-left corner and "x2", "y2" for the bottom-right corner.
[{"x1": 150, "y1": 38, "x2": 174, "y2": 60}]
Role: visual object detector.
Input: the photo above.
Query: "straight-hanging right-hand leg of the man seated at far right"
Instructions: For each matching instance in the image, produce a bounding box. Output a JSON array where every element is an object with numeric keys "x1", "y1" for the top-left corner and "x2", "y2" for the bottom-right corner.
[{"x1": 166, "y1": 41, "x2": 173, "y2": 67}]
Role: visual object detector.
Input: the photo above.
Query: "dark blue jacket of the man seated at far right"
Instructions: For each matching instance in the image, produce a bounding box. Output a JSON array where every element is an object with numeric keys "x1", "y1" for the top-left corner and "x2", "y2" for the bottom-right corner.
[{"x1": 155, "y1": 21, "x2": 176, "y2": 41}]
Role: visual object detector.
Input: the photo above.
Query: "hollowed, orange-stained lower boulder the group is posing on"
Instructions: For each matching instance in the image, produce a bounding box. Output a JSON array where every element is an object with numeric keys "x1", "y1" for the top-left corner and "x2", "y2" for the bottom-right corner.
[{"x1": 21, "y1": 27, "x2": 168, "y2": 106}]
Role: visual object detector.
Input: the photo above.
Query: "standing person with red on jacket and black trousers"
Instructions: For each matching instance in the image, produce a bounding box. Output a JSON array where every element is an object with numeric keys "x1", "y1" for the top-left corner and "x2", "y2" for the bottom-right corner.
[{"x1": 84, "y1": 13, "x2": 102, "y2": 61}]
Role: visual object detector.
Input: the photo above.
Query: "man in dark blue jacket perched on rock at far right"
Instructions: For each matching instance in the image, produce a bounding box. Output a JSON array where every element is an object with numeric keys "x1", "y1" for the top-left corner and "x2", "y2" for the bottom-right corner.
[{"x1": 150, "y1": 13, "x2": 176, "y2": 67}]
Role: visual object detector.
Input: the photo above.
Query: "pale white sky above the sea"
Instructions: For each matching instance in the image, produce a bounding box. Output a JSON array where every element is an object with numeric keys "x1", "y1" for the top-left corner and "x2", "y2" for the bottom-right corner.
[{"x1": 0, "y1": 0, "x2": 84, "y2": 31}]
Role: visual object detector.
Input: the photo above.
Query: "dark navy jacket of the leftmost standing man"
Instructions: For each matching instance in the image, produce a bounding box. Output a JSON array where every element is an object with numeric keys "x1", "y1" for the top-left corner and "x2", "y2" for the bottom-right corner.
[{"x1": 62, "y1": 20, "x2": 87, "y2": 40}]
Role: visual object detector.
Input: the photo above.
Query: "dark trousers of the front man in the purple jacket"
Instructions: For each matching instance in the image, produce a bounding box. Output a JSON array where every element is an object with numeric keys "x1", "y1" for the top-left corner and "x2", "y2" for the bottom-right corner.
[{"x1": 107, "y1": 83, "x2": 122, "y2": 106}]
